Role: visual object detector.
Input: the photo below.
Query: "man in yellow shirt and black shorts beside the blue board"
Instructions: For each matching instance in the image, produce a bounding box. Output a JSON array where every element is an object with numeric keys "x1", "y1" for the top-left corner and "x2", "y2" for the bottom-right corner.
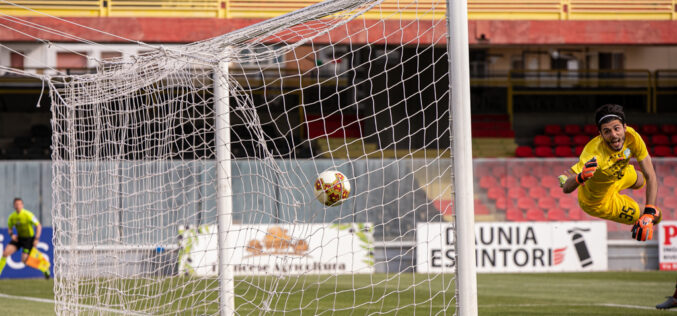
[{"x1": 0, "y1": 198, "x2": 49, "y2": 279}]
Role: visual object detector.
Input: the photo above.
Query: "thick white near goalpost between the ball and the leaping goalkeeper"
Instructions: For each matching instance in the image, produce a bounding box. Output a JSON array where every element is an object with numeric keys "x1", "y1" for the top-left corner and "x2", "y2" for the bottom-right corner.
[{"x1": 447, "y1": 0, "x2": 477, "y2": 316}]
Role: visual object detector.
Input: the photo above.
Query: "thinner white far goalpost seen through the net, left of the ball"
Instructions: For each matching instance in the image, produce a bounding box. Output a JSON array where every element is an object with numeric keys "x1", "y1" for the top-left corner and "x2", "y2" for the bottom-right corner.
[{"x1": 214, "y1": 60, "x2": 235, "y2": 316}]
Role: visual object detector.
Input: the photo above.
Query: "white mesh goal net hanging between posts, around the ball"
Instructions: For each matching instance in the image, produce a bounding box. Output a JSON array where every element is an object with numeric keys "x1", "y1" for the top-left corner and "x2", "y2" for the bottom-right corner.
[{"x1": 43, "y1": 0, "x2": 470, "y2": 315}]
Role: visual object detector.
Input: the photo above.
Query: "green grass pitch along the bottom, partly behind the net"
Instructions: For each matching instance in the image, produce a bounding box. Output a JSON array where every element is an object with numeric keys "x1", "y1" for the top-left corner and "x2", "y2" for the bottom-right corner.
[{"x1": 0, "y1": 271, "x2": 677, "y2": 315}]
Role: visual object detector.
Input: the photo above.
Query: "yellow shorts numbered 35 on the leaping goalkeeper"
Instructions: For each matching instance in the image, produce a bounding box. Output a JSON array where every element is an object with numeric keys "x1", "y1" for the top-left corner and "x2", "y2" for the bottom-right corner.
[{"x1": 578, "y1": 165, "x2": 642, "y2": 225}]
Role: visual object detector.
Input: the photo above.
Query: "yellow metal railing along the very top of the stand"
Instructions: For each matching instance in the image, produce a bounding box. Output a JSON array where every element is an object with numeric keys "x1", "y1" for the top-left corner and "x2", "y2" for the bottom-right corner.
[{"x1": 0, "y1": 0, "x2": 677, "y2": 20}]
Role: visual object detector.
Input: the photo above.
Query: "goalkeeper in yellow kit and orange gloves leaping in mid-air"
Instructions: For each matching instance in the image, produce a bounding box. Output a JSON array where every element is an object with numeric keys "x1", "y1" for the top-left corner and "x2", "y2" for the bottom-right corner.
[{"x1": 559, "y1": 104, "x2": 677, "y2": 309}]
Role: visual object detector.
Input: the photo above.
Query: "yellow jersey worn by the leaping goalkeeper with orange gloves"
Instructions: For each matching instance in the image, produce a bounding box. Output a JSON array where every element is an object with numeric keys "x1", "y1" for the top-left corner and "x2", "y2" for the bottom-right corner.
[{"x1": 571, "y1": 126, "x2": 649, "y2": 205}]
